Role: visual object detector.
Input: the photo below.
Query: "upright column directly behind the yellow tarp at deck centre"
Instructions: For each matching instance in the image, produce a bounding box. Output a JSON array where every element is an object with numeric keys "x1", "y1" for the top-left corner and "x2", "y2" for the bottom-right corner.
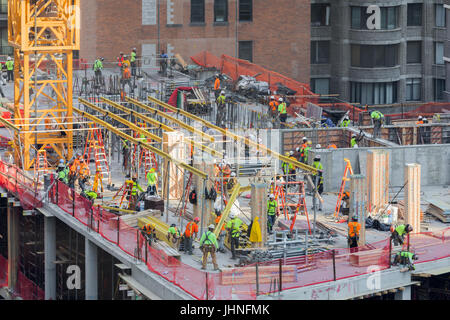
[{"x1": 250, "y1": 182, "x2": 267, "y2": 248}]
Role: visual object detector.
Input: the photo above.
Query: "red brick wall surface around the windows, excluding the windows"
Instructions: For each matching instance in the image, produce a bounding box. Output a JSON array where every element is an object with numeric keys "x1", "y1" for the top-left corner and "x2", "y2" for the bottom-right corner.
[{"x1": 80, "y1": 0, "x2": 310, "y2": 83}]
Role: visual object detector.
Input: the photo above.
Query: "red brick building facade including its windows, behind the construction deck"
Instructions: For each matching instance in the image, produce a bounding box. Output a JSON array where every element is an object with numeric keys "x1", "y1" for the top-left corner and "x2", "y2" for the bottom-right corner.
[{"x1": 80, "y1": 0, "x2": 310, "y2": 83}]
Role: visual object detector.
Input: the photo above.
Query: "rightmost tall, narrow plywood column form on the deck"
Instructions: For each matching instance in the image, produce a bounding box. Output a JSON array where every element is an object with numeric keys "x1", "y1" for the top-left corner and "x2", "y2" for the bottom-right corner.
[{"x1": 405, "y1": 163, "x2": 421, "y2": 232}]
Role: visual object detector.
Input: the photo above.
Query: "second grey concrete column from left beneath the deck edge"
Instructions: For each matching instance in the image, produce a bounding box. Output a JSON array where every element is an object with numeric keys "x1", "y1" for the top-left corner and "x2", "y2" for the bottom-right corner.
[{"x1": 44, "y1": 217, "x2": 56, "y2": 300}]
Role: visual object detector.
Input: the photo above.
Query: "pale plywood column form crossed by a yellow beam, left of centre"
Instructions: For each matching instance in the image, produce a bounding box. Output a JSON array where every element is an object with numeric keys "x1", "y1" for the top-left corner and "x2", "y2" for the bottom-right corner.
[{"x1": 163, "y1": 131, "x2": 186, "y2": 200}]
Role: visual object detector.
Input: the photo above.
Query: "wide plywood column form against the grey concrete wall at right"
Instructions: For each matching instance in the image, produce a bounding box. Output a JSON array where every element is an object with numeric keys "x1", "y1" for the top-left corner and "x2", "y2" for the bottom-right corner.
[{"x1": 366, "y1": 150, "x2": 389, "y2": 212}]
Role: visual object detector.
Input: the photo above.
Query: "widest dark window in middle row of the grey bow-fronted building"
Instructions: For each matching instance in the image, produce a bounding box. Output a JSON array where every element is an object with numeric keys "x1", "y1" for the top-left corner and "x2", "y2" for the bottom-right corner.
[{"x1": 351, "y1": 44, "x2": 398, "y2": 68}]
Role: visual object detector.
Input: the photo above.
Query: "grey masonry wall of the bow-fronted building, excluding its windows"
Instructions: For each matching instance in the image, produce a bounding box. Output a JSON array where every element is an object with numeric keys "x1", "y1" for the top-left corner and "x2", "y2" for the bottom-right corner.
[{"x1": 311, "y1": 0, "x2": 448, "y2": 102}]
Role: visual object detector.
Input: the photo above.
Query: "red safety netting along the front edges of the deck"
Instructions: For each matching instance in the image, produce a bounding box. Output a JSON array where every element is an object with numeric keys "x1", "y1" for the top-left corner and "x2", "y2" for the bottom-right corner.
[{"x1": 0, "y1": 161, "x2": 450, "y2": 300}]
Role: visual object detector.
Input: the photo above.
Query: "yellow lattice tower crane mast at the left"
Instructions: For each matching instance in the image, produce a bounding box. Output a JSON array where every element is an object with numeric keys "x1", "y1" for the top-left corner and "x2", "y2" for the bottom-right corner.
[{"x1": 8, "y1": 0, "x2": 80, "y2": 170}]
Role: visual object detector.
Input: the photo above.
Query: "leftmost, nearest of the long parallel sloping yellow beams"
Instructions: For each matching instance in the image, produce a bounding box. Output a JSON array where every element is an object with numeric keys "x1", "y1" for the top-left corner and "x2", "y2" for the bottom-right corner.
[{"x1": 73, "y1": 107, "x2": 208, "y2": 179}]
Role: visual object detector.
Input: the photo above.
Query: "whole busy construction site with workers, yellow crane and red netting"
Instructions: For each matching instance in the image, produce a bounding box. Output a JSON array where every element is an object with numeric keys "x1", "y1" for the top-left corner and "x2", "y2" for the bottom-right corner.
[{"x1": 0, "y1": 0, "x2": 450, "y2": 300}]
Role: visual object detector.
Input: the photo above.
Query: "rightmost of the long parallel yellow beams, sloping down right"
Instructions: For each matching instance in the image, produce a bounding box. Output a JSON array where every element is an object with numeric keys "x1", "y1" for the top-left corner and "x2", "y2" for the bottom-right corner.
[{"x1": 148, "y1": 96, "x2": 317, "y2": 173}]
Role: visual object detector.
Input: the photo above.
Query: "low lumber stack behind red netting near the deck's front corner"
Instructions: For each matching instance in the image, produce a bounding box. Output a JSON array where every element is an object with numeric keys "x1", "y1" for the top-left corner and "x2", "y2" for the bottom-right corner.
[{"x1": 221, "y1": 265, "x2": 297, "y2": 285}]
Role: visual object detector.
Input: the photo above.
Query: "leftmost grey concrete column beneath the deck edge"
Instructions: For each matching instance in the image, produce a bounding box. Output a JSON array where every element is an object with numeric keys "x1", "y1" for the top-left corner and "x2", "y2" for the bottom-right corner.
[{"x1": 7, "y1": 198, "x2": 20, "y2": 291}]
